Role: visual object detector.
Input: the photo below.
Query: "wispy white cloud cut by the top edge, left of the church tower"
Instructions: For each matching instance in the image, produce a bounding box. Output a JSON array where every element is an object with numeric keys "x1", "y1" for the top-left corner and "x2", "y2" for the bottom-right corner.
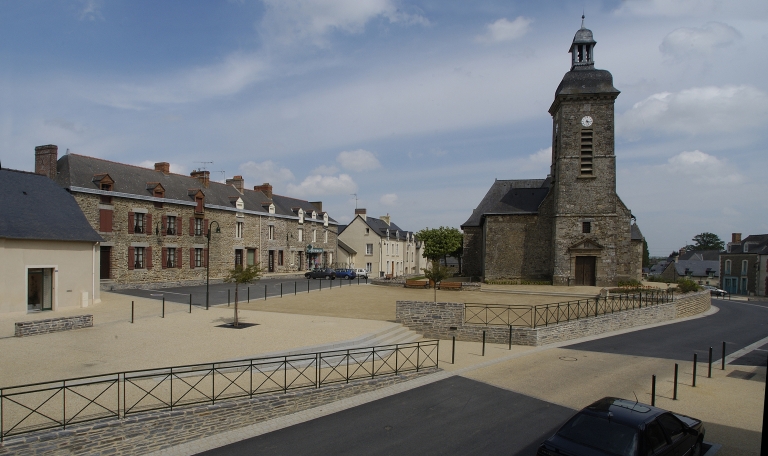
[{"x1": 263, "y1": 0, "x2": 429, "y2": 46}]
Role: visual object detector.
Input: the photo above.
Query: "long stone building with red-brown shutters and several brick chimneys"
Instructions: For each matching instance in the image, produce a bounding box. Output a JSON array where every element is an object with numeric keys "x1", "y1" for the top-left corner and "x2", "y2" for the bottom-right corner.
[{"x1": 35, "y1": 145, "x2": 337, "y2": 287}]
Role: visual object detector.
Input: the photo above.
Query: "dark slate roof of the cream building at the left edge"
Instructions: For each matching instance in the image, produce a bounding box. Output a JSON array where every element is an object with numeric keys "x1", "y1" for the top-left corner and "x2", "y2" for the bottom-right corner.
[{"x1": 0, "y1": 169, "x2": 103, "y2": 242}]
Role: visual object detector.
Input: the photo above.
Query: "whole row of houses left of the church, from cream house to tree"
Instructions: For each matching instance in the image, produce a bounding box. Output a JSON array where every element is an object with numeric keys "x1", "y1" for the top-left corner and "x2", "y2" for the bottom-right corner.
[{"x1": 0, "y1": 145, "x2": 422, "y2": 312}]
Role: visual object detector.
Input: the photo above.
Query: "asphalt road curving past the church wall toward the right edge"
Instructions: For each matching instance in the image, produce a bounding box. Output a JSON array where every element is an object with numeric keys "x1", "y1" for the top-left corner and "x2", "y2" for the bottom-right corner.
[{"x1": 564, "y1": 299, "x2": 768, "y2": 365}]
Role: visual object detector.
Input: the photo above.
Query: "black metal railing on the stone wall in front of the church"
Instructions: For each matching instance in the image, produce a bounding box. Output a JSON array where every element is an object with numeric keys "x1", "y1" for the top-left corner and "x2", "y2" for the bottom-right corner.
[{"x1": 464, "y1": 290, "x2": 674, "y2": 328}]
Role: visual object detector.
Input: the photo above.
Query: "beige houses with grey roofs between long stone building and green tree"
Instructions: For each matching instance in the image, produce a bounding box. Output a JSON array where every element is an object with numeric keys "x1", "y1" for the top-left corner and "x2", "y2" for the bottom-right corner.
[{"x1": 339, "y1": 209, "x2": 426, "y2": 277}]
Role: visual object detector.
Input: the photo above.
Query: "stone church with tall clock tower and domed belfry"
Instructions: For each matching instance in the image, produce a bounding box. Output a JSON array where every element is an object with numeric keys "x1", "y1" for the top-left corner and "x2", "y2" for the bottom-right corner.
[{"x1": 461, "y1": 22, "x2": 643, "y2": 286}]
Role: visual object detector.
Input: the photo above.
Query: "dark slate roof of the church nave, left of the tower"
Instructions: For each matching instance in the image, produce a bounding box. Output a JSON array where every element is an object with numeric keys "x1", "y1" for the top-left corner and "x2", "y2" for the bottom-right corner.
[{"x1": 461, "y1": 178, "x2": 550, "y2": 228}]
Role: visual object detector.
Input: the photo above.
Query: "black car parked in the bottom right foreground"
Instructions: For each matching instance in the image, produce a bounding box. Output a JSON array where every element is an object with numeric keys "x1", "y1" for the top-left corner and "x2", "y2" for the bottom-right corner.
[{"x1": 536, "y1": 397, "x2": 704, "y2": 456}]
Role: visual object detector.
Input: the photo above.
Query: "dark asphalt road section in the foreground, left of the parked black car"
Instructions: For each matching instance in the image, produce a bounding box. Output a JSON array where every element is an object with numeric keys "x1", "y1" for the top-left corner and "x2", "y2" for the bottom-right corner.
[{"x1": 200, "y1": 377, "x2": 575, "y2": 456}]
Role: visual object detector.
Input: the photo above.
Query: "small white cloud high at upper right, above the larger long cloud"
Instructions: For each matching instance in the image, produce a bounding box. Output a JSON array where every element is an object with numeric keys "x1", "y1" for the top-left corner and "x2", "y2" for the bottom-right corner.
[{"x1": 659, "y1": 22, "x2": 741, "y2": 58}]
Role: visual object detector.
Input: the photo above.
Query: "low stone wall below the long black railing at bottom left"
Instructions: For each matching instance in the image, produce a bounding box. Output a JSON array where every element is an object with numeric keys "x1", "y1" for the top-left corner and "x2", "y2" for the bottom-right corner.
[{"x1": 0, "y1": 368, "x2": 438, "y2": 455}]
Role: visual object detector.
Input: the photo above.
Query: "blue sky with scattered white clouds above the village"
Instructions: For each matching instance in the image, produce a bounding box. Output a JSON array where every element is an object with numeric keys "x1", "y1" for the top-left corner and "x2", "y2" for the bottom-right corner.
[{"x1": 0, "y1": 0, "x2": 768, "y2": 256}]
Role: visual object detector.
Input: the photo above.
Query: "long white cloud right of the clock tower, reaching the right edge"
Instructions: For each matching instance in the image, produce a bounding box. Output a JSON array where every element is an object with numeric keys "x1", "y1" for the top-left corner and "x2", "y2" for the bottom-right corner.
[{"x1": 616, "y1": 85, "x2": 768, "y2": 138}]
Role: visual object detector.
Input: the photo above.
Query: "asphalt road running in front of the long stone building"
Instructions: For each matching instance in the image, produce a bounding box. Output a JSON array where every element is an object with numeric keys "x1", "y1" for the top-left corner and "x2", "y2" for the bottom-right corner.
[{"x1": 113, "y1": 278, "x2": 367, "y2": 306}]
